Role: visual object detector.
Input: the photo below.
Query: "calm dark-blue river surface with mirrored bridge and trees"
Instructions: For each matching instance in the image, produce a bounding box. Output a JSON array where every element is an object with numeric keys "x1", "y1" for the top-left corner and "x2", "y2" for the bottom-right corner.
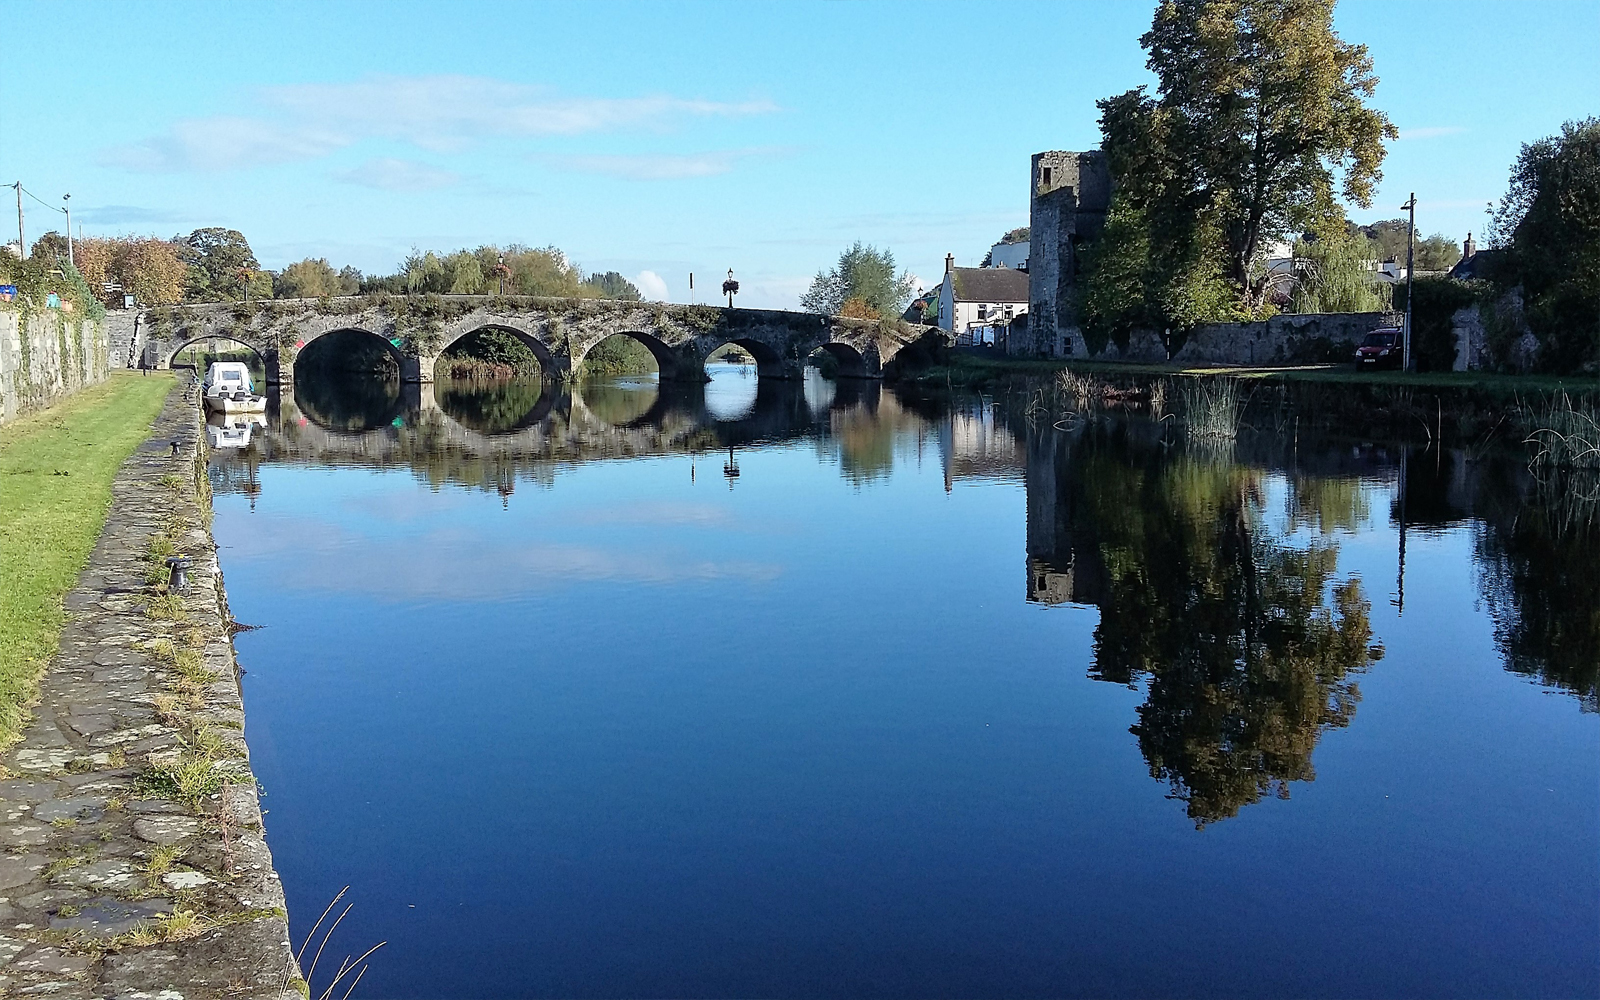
[{"x1": 213, "y1": 366, "x2": 1600, "y2": 997}]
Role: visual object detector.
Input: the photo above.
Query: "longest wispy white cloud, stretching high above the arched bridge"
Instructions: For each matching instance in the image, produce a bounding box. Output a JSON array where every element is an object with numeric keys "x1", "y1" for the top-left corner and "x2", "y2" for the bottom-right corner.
[{"x1": 101, "y1": 75, "x2": 778, "y2": 173}]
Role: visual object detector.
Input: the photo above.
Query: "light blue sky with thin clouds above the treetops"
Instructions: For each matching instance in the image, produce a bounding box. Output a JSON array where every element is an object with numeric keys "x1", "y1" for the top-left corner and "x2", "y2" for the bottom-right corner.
[{"x1": 0, "y1": 0, "x2": 1600, "y2": 307}]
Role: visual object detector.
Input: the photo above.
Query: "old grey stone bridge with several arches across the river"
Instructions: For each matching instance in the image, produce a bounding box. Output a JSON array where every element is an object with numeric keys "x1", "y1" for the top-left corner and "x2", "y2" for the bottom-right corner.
[{"x1": 137, "y1": 294, "x2": 939, "y2": 384}]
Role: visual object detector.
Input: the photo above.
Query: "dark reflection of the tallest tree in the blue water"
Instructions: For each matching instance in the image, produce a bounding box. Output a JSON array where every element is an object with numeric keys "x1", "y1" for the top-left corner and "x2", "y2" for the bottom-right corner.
[{"x1": 1030, "y1": 437, "x2": 1376, "y2": 827}]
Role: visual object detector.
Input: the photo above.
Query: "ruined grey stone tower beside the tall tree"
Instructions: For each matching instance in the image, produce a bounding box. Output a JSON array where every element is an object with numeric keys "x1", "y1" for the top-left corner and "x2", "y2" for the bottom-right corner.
[{"x1": 1013, "y1": 150, "x2": 1110, "y2": 357}]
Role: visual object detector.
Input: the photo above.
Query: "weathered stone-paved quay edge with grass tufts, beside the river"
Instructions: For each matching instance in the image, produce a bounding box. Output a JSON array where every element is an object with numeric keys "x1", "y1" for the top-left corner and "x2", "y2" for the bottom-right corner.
[{"x1": 0, "y1": 389, "x2": 304, "y2": 1000}]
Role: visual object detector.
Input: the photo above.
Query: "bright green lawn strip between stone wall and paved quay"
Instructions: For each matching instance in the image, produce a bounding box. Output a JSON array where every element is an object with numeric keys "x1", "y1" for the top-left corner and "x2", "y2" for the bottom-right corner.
[{"x1": 0, "y1": 373, "x2": 173, "y2": 747}]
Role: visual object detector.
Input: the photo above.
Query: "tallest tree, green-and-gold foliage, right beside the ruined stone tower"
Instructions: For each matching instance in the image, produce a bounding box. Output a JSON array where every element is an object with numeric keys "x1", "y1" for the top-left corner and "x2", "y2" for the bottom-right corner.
[{"x1": 1099, "y1": 0, "x2": 1397, "y2": 318}]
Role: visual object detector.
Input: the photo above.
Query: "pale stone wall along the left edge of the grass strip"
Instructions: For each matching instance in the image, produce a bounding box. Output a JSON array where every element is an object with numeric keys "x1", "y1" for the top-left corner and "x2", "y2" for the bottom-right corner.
[{"x1": 0, "y1": 302, "x2": 110, "y2": 424}]
